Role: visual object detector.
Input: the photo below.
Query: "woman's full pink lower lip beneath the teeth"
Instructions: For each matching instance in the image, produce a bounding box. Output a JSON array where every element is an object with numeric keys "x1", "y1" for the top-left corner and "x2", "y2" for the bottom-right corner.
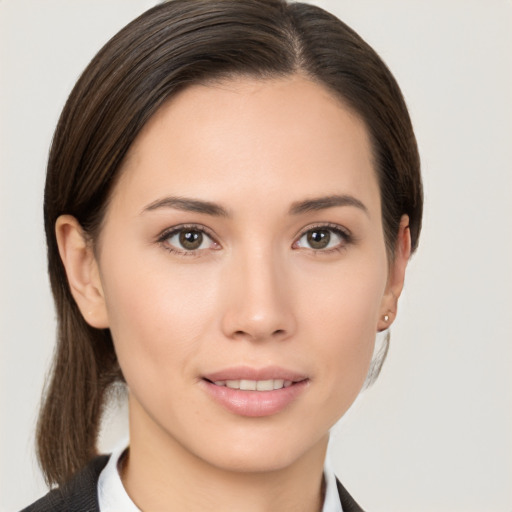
[{"x1": 202, "y1": 379, "x2": 309, "y2": 418}]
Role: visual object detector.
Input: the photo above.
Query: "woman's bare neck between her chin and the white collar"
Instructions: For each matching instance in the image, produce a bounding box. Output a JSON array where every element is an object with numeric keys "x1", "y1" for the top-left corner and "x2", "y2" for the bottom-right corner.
[{"x1": 121, "y1": 400, "x2": 328, "y2": 512}]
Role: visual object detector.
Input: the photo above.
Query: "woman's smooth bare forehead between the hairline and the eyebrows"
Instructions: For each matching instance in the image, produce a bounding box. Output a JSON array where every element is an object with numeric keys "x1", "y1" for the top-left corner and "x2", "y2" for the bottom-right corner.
[{"x1": 114, "y1": 76, "x2": 379, "y2": 218}]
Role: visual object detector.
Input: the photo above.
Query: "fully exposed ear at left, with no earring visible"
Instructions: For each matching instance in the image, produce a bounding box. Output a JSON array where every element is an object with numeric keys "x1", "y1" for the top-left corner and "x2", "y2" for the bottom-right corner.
[{"x1": 55, "y1": 215, "x2": 109, "y2": 329}]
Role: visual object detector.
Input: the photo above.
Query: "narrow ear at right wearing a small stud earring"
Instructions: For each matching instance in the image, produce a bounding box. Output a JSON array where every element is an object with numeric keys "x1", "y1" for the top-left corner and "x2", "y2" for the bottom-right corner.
[{"x1": 377, "y1": 215, "x2": 411, "y2": 331}]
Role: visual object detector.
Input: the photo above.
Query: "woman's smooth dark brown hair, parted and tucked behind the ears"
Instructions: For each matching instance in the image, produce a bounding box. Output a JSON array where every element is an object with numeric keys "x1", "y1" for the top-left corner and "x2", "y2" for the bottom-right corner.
[{"x1": 37, "y1": 0, "x2": 422, "y2": 484}]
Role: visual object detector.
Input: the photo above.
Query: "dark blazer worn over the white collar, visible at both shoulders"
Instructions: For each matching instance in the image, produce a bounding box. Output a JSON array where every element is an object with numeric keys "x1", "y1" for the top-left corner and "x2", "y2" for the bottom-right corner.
[{"x1": 21, "y1": 455, "x2": 363, "y2": 512}]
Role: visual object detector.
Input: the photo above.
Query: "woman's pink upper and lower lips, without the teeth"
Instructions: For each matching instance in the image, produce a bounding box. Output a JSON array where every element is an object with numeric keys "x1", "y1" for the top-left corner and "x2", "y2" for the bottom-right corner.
[{"x1": 201, "y1": 367, "x2": 309, "y2": 417}]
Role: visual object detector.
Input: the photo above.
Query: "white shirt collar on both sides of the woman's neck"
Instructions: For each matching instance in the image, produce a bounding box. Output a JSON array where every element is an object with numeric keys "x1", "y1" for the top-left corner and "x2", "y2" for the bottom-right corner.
[{"x1": 98, "y1": 443, "x2": 343, "y2": 512}]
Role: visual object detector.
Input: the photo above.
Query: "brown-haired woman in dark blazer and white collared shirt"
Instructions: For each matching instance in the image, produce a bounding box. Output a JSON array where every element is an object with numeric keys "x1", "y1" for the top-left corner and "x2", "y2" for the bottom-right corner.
[{"x1": 22, "y1": 0, "x2": 422, "y2": 512}]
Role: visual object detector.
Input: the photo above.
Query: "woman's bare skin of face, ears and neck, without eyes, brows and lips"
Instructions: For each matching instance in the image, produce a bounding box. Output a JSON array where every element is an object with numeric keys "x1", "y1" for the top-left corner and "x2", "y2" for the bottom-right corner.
[{"x1": 56, "y1": 75, "x2": 410, "y2": 511}]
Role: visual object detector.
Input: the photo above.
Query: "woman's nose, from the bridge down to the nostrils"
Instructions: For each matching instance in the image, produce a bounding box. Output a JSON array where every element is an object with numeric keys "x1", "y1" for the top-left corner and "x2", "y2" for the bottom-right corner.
[{"x1": 222, "y1": 246, "x2": 296, "y2": 341}]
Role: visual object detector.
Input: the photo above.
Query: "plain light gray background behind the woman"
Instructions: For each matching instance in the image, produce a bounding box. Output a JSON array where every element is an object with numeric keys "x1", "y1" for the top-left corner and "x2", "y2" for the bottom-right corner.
[{"x1": 0, "y1": 0, "x2": 512, "y2": 512}]
